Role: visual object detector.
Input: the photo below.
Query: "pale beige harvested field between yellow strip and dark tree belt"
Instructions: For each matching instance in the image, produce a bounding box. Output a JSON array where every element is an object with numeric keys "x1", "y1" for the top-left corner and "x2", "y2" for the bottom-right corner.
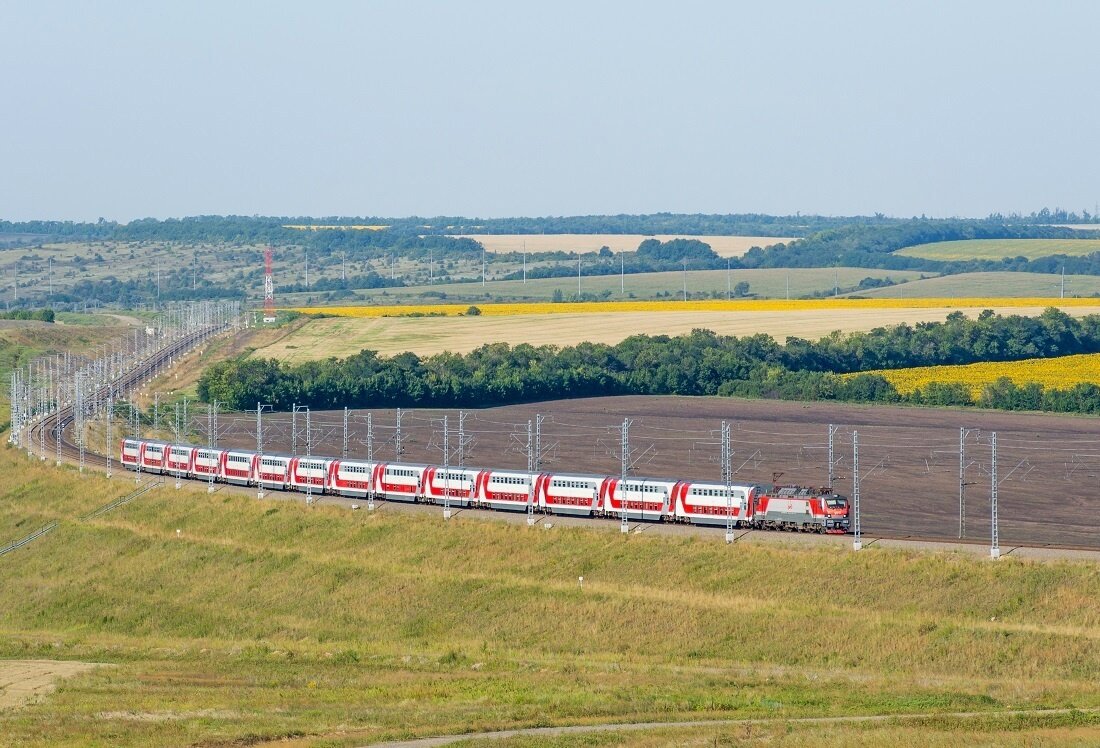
[{"x1": 255, "y1": 305, "x2": 1096, "y2": 362}]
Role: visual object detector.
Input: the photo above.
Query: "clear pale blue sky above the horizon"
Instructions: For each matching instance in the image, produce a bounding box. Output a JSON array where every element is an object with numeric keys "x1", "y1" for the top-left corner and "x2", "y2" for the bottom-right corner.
[{"x1": 0, "y1": 0, "x2": 1100, "y2": 221}]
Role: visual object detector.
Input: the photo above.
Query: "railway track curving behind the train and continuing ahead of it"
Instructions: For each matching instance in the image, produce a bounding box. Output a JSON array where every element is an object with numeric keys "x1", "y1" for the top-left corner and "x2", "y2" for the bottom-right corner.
[{"x1": 17, "y1": 325, "x2": 1100, "y2": 552}]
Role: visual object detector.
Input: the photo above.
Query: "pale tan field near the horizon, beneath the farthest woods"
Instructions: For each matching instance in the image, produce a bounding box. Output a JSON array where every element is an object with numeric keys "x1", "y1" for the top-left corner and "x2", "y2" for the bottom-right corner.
[{"x1": 446, "y1": 234, "x2": 793, "y2": 257}]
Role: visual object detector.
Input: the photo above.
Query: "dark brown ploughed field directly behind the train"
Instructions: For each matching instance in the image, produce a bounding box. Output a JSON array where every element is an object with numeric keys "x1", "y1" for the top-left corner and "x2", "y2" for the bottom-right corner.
[{"x1": 210, "y1": 397, "x2": 1100, "y2": 548}]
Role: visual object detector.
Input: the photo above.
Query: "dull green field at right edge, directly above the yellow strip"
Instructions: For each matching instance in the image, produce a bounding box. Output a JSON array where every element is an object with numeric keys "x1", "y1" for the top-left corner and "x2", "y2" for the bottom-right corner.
[{"x1": 858, "y1": 273, "x2": 1100, "y2": 298}]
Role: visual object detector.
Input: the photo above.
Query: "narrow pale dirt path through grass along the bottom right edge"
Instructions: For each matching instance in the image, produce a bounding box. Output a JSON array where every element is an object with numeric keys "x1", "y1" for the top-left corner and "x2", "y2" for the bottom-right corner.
[{"x1": 363, "y1": 710, "x2": 1100, "y2": 748}]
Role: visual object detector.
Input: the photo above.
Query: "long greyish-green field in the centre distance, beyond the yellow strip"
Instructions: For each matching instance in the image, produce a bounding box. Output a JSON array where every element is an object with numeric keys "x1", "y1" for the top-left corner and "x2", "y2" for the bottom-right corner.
[{"x1": 279, "y1": 267, "x2": 928, "y2": 306}]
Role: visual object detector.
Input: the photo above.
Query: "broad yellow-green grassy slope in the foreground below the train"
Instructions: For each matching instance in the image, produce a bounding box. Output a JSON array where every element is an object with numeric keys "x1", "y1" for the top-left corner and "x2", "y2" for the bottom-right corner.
[{"x1": 0, "y1": 450, "x2": 1100, "y2": 746}]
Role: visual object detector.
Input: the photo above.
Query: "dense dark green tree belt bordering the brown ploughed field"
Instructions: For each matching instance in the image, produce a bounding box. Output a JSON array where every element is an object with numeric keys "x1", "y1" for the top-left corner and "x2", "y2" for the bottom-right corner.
[{"x1": 198, "y1": 308, "x2": 1100, "y2": 413}]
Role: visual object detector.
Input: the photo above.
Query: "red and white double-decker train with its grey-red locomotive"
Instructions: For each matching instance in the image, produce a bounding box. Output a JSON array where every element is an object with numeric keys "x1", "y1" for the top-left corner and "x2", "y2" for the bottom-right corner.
[{"x1": 120, "y1": 439, "x2": 848, "y2": 534}]
